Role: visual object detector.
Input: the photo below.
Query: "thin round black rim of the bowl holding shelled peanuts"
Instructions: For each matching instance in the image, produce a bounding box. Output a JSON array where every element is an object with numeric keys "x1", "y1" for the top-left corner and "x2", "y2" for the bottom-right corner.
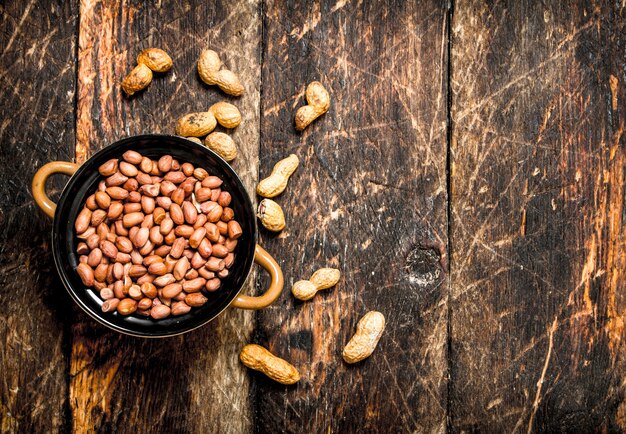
[{"x1": 51, "y1": 134, "x2": 258, "y2": 339}]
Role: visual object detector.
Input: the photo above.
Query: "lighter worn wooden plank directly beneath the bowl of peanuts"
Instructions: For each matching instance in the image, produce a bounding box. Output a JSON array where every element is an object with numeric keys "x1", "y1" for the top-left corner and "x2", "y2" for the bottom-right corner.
[{"x1": 70, "y1": 0, "x2": 261, "y2": 433}]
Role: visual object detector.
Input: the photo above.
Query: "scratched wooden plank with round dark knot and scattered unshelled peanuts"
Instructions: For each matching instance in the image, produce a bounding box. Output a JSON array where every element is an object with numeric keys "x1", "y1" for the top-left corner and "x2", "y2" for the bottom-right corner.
[{"x1": 251, "y1": 1, "x2": 448, "y2": 432}]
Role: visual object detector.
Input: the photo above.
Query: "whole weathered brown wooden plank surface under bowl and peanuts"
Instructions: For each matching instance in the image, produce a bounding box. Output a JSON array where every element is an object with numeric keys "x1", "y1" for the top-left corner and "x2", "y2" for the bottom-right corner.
[{"x1": 0, "y1": 0, "x2": 626, "y2": 433}]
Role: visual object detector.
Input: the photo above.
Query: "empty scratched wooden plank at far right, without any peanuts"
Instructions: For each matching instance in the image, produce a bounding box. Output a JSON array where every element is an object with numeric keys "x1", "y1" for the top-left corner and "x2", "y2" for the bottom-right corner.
[{"x1": 450, "y1": 0, "x2": 626, "y2": 432}]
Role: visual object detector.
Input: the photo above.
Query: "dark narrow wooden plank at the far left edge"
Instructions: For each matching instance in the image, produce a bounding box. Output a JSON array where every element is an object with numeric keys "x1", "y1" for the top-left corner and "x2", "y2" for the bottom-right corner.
[{"x1": 0, "y1": 1, "x2": 78, "y2": 432}]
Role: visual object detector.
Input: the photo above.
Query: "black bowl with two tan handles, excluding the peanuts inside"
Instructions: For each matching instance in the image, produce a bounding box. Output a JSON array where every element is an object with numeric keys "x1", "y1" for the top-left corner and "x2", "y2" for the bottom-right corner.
[{"x1": 33, "y1": 135, "x2": 283, "y2": 337}]
